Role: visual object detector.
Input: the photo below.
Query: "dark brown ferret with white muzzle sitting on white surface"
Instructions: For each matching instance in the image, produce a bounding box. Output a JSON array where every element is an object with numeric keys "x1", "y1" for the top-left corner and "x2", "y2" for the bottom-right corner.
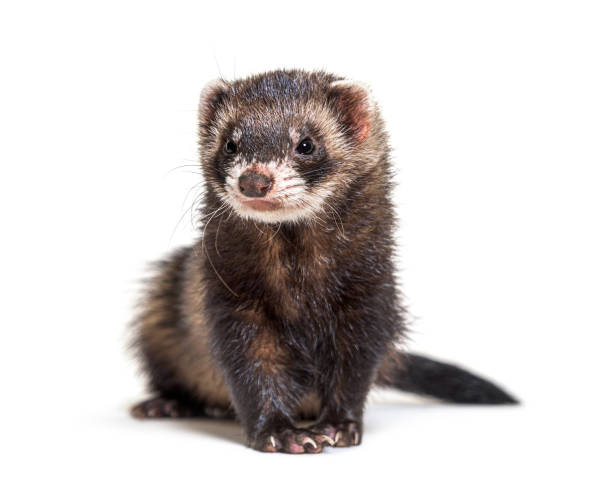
[{"x1": 132, "y1": 70, "x2": 515, "y2": 453}]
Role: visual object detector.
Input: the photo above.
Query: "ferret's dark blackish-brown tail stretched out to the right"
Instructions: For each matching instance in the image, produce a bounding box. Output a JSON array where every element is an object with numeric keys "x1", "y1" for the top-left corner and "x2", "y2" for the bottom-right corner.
[{"x1": 377, "y1": 353, "x2": 518, "y2": 405}]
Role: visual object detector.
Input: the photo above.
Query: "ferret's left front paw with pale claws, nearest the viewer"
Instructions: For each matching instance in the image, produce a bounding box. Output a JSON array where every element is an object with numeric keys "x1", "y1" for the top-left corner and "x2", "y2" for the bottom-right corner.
[{"x1": 250, "y1": 427, "x2": 334, "y2": 454}]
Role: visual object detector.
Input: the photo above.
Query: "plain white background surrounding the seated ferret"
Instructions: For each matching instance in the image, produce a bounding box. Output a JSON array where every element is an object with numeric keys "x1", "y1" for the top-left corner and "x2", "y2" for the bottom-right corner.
[{"x1": 0, "y1": 0, "x2": 612, "y2": 493}]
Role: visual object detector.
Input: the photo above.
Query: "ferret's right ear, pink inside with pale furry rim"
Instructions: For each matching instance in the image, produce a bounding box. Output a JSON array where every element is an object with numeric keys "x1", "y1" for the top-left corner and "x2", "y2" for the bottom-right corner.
[{"x1": 329, "y1": 79, "x2": 375, "y2": 144}]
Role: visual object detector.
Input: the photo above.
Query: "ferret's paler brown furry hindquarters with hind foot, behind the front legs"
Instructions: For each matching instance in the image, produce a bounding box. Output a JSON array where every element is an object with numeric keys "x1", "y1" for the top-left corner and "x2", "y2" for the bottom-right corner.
[{"x1": 131, "y1": 248, "x2": 234, "y2": 418}]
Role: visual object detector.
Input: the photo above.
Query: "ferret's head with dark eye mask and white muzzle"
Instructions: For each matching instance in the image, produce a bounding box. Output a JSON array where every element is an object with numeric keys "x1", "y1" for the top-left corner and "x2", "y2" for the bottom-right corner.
[{"x1": 199, "y1": 71, "x2": 386, "y2": 223}]
